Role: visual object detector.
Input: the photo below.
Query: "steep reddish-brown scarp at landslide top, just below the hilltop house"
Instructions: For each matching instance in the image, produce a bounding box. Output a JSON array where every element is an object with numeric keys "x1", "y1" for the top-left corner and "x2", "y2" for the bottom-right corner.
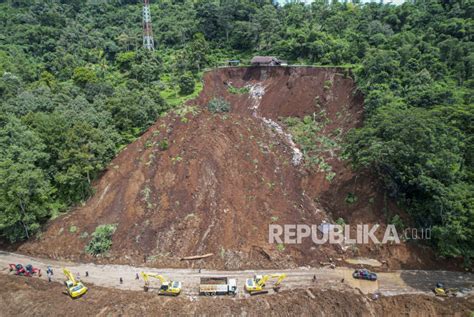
[{"x1": 191, "y1": 67, "x2": 363, "y2": 124}]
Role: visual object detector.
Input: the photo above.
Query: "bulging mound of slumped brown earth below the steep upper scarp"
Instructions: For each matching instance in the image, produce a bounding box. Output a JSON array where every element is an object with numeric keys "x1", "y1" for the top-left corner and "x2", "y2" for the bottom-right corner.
[{"x1": 21, "y1": 112, "x2": 336, "y2": 268}]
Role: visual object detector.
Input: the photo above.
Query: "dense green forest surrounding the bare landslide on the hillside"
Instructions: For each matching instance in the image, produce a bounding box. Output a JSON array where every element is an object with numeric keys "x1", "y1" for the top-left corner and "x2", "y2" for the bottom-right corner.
[{"x1": 0, "y1": 0, "x2": 474, "y2": 265}]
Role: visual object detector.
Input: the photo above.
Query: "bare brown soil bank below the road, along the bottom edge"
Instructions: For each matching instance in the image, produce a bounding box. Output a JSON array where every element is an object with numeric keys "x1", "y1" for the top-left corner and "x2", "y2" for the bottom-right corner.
[{"x1": 0, "y1": 274, "x2": 474, "y2": 316}]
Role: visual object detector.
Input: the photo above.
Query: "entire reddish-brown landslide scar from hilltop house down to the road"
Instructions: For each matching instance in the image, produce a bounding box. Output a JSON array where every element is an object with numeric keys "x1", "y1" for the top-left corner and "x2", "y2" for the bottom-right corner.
[{"x1": 18, "y1": 67, "x2": 448, "y2": 269}]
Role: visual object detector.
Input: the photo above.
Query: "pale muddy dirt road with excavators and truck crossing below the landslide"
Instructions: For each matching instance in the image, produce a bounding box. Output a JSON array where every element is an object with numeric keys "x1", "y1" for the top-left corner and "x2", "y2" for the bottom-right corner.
[{"x1": 0, "y1": 251, "x2": 474, "y2": 297}]
